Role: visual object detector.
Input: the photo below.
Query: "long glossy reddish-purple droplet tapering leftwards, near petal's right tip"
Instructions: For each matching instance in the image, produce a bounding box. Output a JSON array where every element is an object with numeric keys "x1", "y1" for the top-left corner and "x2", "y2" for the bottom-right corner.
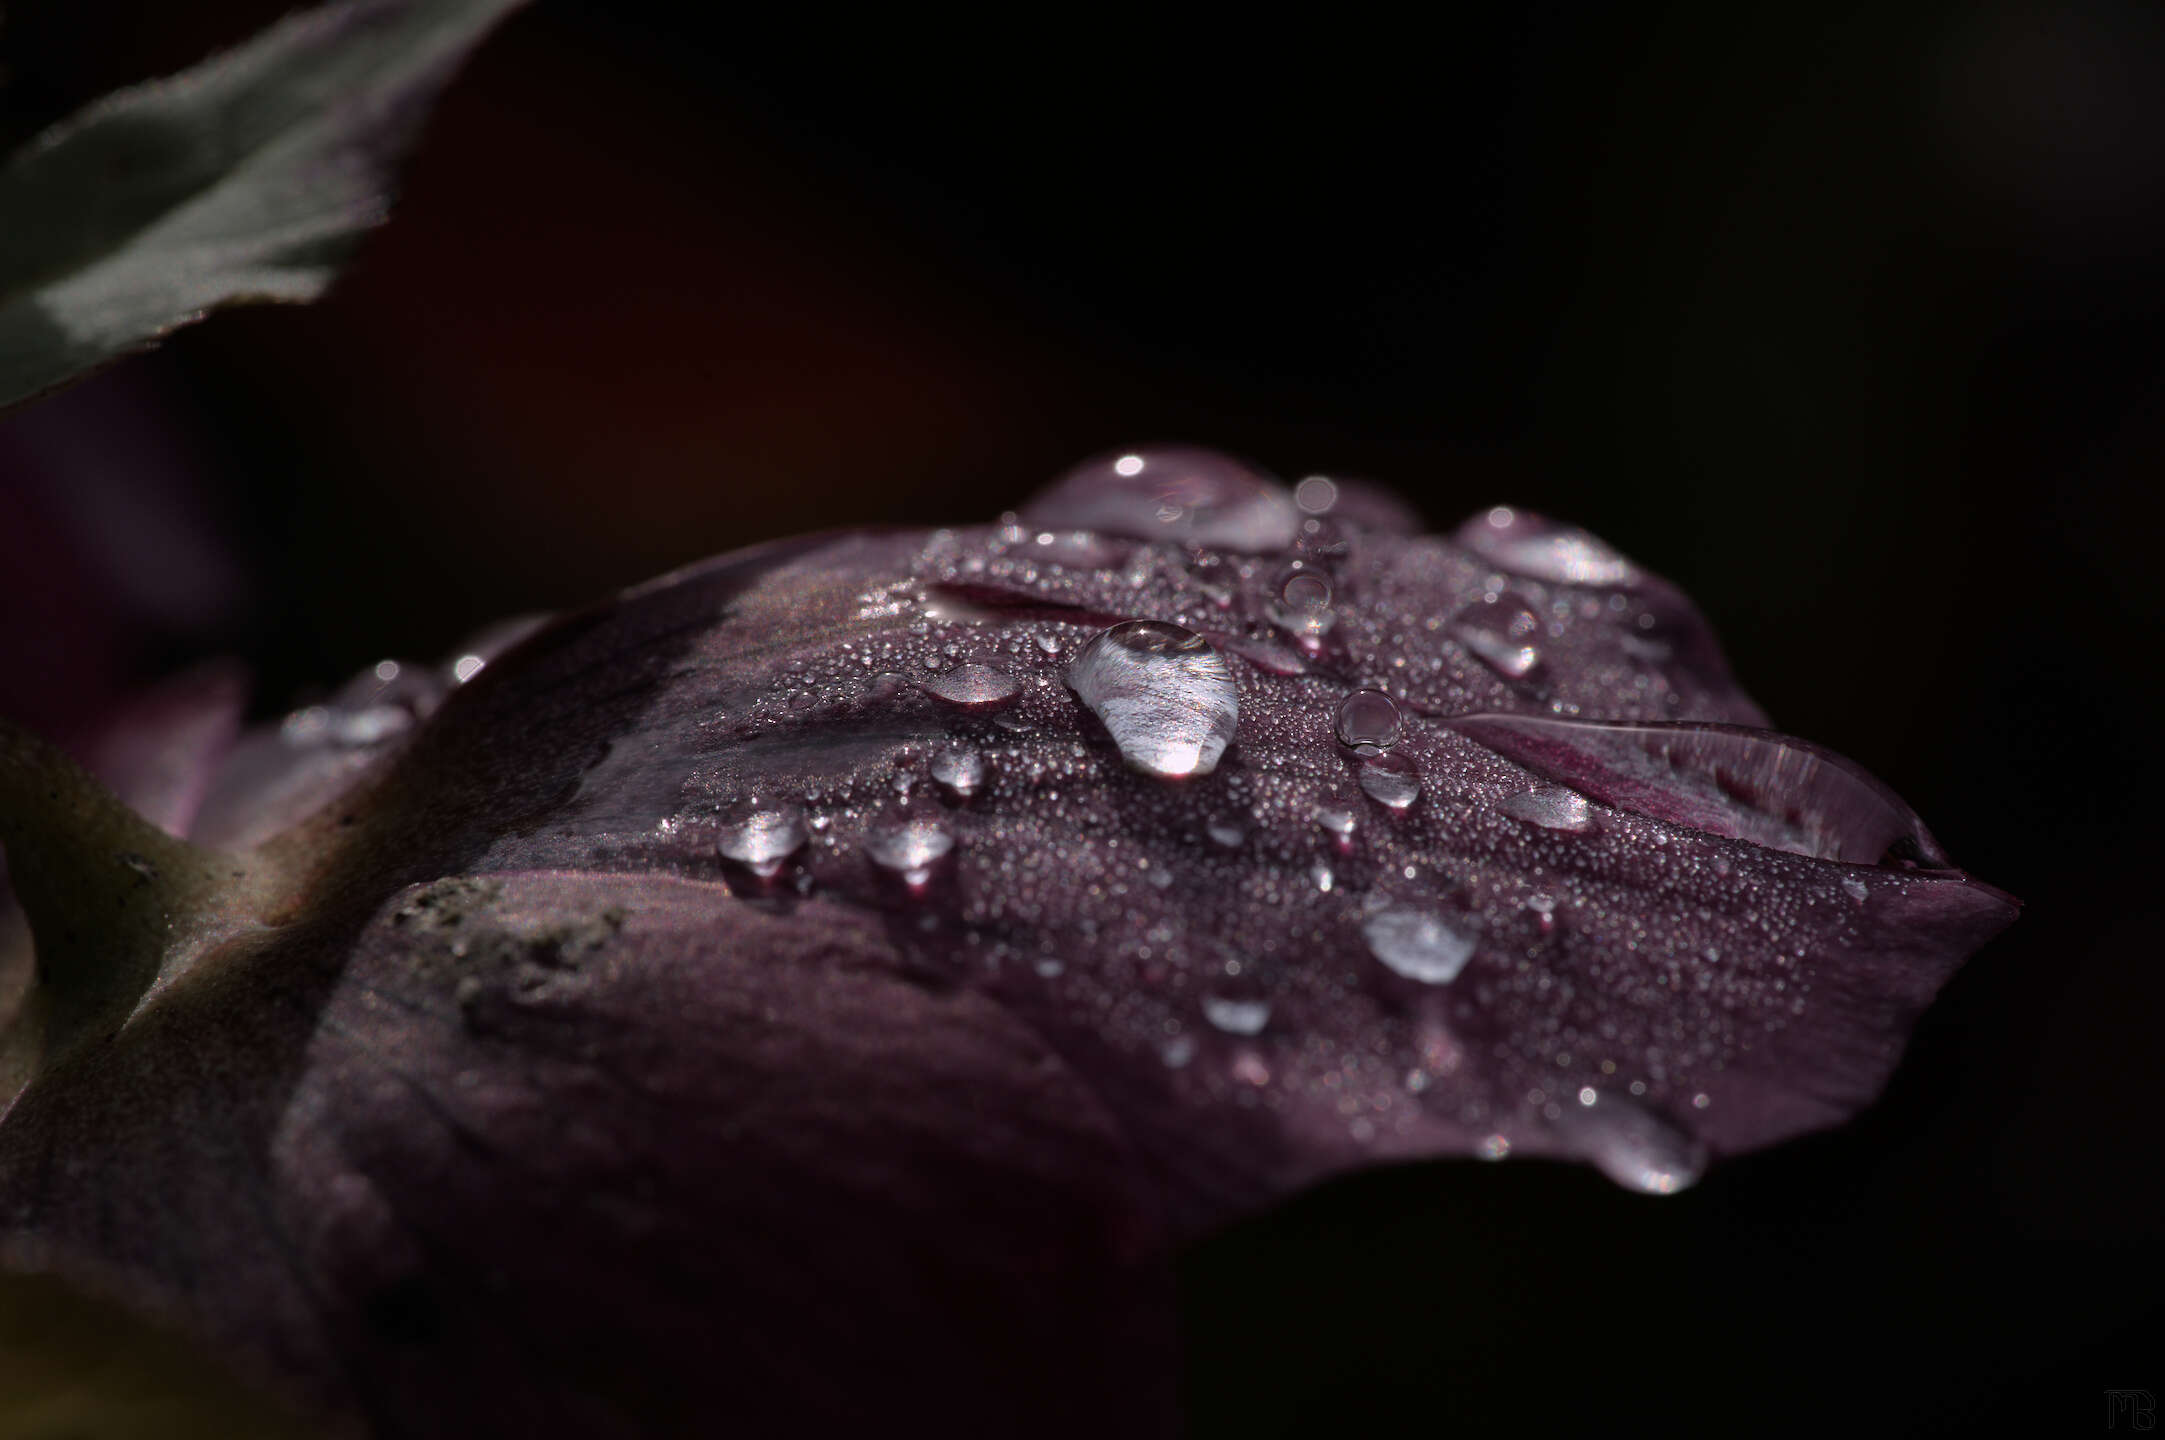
[{"x1": 1444, "y1": 715, "x2": 1949, "y2": 866}]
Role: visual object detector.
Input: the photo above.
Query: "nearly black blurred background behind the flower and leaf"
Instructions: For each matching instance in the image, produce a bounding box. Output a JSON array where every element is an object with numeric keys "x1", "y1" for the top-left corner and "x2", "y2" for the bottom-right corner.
[{"x1": 0, "y1": 0, "x2": 2165, "y2": 1440}]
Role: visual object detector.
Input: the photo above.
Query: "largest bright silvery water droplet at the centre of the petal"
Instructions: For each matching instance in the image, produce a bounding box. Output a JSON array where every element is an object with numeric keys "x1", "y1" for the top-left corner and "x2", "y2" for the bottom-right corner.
[{"x1": 1065, "y1": 619, "x2": 1241, "y2": 780}]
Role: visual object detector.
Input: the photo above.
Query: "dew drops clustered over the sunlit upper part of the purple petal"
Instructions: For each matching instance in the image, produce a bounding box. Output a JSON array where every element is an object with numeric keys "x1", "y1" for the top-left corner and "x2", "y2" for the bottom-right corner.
[{"x1": 286, "y1": 448, "x2": 1948, "y2": 1193}]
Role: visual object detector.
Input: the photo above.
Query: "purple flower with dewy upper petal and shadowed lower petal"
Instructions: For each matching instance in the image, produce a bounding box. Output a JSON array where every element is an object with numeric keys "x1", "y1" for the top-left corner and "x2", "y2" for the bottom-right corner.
[{"x1": 0, "y1": 459, "x2": 2013, "y2": 1434}]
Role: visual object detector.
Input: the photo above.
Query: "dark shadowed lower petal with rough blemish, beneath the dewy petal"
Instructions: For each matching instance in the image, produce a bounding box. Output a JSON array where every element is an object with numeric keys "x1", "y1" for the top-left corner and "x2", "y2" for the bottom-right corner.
[{"x1": 0, "y1": 873, "x2": 1171, "y2": 1436}]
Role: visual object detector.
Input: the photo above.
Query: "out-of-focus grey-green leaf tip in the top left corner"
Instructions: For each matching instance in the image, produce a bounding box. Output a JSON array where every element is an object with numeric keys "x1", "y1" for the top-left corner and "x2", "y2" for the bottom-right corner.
[{"x1": 0, "y1": 0, "x2": 524, "y2": 409}]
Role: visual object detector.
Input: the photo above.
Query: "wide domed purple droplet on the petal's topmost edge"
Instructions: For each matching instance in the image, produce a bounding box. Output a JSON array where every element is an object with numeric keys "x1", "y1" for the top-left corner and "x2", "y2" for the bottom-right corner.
[{"x1": 1022, "y1": 446, "x2": 1301, "y2": 554}]
